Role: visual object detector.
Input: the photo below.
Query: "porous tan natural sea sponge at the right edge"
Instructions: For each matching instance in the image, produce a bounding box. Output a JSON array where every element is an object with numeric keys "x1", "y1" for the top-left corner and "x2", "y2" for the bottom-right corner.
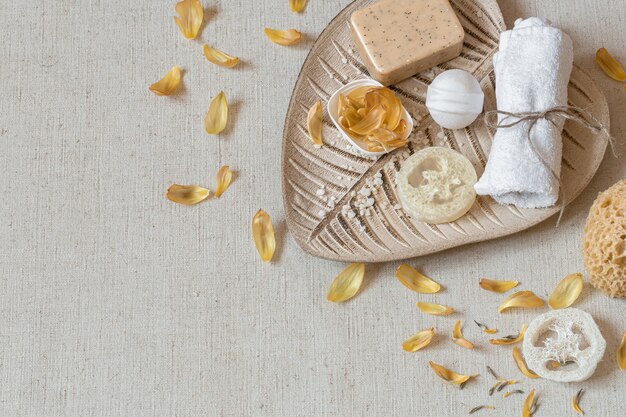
[{"x1": 583, "y1": 180, "x2": 626, "y2": 297}]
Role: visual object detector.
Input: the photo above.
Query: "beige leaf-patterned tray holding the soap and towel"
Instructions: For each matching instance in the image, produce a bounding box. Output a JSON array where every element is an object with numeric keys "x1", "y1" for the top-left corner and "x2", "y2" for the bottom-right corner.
[{"x1": 282, "y1": 0, "x2": 609, "y2": 262}]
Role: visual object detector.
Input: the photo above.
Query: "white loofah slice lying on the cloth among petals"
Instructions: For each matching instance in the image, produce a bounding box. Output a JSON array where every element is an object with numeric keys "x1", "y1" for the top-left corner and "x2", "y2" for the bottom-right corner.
[{"x1": 523, "y1": 308, "x2": 606, "y2": 382}]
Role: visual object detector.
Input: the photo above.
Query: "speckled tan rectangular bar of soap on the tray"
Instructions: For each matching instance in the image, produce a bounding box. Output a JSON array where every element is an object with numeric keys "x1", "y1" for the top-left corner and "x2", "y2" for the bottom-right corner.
[{"x1": 350, "y1": 0, "x2": 465, "y2": 85}]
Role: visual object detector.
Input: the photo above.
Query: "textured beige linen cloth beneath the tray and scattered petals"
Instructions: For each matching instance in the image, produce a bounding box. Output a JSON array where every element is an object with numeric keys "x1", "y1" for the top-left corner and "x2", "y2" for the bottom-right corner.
[{"x1": 0, "y1": 0, "x2": 626, "y2": 417}]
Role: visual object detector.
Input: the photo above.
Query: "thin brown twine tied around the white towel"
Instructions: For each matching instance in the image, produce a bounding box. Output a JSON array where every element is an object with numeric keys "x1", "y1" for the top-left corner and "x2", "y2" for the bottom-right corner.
[{"x1": 484, "y1": 106, "x2": 618, "y2": 227}]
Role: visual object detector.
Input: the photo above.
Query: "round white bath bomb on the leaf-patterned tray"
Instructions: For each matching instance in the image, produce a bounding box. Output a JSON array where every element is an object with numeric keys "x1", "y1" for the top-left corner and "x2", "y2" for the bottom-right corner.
[{"x1": 426, "y1": 69, "x2": 485, "y2": 129}]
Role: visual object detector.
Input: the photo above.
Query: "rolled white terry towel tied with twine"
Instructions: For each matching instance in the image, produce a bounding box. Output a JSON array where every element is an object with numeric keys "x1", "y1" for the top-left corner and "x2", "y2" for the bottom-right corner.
[{"x1": 475, "y1": 17, "x2": 574, "y2": 208}]
